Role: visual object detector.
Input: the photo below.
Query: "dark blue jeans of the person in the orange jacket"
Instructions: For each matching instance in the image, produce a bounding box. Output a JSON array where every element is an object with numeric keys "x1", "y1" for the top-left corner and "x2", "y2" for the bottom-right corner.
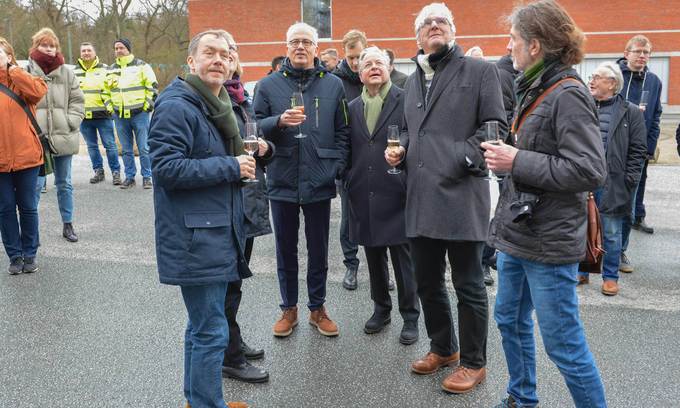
[{"x1": 0, "y1": 166, "x2": 40, "y2": 260}]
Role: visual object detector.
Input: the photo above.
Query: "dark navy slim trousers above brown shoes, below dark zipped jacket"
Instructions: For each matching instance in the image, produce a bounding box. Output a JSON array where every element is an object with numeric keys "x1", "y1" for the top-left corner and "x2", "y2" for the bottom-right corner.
[{"x1": 270, "y1": 199, "x2": 331, "y2": 310}]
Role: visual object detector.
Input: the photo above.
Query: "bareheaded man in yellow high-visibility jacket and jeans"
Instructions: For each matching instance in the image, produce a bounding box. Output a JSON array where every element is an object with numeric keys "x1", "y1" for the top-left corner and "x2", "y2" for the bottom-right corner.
[{"x1": 74, "y1": 42, "x2": 121, "y2": 186}]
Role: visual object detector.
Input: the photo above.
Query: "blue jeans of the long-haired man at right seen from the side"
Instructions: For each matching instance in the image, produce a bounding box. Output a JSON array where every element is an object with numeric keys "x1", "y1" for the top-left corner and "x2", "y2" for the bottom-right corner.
[{"x1": 494, "y1": 252, "x2": 607, "y2": 408}]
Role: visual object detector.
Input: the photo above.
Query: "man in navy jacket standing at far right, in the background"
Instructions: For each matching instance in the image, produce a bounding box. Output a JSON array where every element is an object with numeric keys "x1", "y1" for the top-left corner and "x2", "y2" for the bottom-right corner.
[{"x1": 617, "y1": 35, "x2": 662, "y2": 273}]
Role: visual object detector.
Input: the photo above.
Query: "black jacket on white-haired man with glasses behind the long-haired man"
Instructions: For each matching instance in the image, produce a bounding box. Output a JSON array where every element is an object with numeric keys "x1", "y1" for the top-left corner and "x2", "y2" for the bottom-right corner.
[{"x1": 598, "y1": 94, "x2": 647, "y2": 217}]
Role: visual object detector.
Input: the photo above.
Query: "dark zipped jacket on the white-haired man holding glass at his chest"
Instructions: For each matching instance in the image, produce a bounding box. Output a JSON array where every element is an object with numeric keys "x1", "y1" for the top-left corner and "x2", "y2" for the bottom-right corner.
[{"x1": 254, "y1": 59, "x2": 349, "y2": 204}]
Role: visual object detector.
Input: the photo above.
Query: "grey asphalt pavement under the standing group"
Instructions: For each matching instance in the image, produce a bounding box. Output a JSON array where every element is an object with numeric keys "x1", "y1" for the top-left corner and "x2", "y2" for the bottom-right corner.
[{"x1": 0, "y1": 155, "x2": 680, "y2": 408}]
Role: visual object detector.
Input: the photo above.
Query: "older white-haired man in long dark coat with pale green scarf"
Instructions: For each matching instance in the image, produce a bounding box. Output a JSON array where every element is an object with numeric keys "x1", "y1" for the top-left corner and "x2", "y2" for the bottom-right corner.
[{"x1": 346, "y1": 47, "x2": 420, "y2": 345}]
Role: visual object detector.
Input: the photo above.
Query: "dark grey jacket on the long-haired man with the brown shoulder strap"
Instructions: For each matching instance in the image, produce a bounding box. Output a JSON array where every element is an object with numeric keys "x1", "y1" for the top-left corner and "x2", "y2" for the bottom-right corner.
[{"x1": 489, "y1": 68, "x2": 607, "y2": 264}]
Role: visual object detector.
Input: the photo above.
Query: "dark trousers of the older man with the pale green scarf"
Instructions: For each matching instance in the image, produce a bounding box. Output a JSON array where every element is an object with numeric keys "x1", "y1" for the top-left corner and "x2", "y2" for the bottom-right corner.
[{"x1": 364, "y1": 244, "x2": 420, "y2": 322}]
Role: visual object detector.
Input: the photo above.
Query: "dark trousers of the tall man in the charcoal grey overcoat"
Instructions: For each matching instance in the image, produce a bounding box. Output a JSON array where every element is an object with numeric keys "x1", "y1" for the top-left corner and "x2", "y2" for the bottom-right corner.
[{"x1": 411, "y1": 237, "x2": 489, "y2": 368}]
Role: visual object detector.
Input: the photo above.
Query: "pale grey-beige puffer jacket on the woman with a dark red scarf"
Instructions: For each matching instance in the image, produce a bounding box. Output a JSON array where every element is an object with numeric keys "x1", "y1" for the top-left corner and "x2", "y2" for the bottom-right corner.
[{"x1": 27, "y1": 60, "x2": 85, "y2": 156}]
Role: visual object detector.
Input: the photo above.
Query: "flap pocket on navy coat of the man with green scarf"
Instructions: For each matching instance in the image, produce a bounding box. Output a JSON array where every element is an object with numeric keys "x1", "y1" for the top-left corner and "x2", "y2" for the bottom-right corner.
[{"x1": 184, "y1": 213, "x2": 236, "y2": 271}]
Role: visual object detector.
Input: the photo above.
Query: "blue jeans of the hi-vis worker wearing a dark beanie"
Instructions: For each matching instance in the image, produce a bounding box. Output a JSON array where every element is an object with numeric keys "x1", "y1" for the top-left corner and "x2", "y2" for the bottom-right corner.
[{"x1": 114, "y1": 112, "x2": 151, "y2": 179}]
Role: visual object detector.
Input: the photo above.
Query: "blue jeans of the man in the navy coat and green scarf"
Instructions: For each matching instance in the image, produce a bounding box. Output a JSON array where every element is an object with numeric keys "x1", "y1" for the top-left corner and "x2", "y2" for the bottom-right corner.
[{"x1": 181, "y1": 283, "x2": 229, "y2": 408}]
